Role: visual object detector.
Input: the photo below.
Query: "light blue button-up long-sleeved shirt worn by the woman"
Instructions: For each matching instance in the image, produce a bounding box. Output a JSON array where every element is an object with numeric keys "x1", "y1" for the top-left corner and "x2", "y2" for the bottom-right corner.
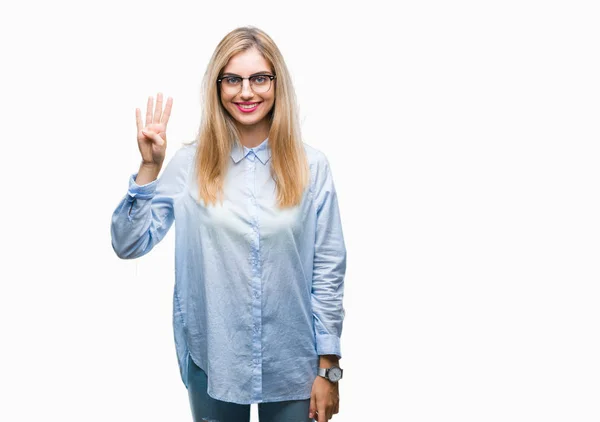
[{"x1": 111, "y1": 138, "x2": 346, "y2": 404}]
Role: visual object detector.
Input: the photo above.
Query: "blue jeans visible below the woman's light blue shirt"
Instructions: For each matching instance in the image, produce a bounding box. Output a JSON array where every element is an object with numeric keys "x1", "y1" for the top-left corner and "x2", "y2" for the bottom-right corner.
[{"x1": 188, "y1": 354, "x2": 314, "y2": 422}]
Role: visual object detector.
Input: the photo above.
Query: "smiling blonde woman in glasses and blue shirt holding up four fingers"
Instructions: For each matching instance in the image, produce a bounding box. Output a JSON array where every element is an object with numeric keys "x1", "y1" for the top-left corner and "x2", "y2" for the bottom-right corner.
[{"x1": 111, "y1": 27, "x2": 346, "y2": 422}]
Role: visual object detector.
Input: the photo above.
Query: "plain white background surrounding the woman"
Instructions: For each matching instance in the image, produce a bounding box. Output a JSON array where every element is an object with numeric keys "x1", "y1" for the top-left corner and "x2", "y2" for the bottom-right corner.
[{"x1": 0, "y1": 0, "x2": 600, "y2": 422}]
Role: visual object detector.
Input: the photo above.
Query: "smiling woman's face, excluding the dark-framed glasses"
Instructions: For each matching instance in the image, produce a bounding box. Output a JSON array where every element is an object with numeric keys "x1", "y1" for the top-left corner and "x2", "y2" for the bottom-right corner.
[{"x1": 219, "y1": 48, "x2": 276, "y2": 128}]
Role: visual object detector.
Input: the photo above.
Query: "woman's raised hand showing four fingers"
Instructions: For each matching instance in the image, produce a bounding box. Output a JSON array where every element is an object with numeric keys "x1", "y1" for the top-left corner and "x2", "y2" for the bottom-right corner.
[{"x1": 135, "y1": 92, "x2": 173, "y2": 170}]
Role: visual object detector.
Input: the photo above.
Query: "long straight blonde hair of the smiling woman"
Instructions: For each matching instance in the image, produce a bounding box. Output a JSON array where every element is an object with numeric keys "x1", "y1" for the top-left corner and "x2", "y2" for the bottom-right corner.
[{"x1": 186, "y1": 26, "x2": 309, "y2": 208}]
